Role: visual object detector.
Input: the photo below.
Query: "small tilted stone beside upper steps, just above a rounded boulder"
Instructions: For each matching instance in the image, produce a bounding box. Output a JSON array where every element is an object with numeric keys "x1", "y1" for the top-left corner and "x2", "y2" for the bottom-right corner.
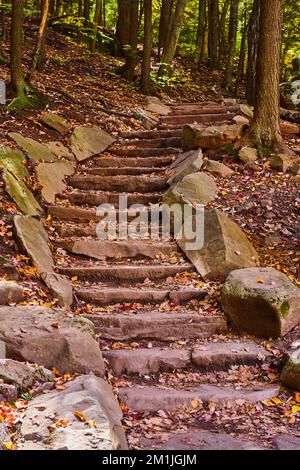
[{"x1": 168, "y1": 149, "x2": 203, "y2": 186}]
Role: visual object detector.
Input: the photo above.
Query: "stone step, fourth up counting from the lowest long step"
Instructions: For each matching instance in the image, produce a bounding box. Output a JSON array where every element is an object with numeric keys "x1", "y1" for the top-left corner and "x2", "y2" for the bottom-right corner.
[{"x1": 76, "y1": 287, "x2": 206, "y2": 306}]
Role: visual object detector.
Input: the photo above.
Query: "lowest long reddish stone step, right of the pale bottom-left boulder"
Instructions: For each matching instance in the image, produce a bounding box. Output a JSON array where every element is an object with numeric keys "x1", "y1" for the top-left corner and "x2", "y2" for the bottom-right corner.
[{"x1": 119, "y1": 384, "x2": 280, "y2": 413}]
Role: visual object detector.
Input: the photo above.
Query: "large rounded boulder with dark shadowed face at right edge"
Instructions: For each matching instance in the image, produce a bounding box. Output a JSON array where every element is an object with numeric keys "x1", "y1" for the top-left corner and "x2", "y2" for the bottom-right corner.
[{"x1": 221, "y1": 268, "x2": 300, "y2": 338}]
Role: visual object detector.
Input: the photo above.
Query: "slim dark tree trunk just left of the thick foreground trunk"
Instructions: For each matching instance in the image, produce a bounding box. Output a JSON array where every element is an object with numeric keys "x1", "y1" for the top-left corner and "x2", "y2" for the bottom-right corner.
[{"x1": 246, "y1": 0, "x2": 261, "y2": 105}]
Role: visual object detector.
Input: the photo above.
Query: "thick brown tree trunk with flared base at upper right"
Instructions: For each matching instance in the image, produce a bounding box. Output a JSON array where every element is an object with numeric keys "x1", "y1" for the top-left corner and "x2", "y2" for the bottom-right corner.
[{"x1": 249, "y1": 0, "x2": 284, "y2": 150}]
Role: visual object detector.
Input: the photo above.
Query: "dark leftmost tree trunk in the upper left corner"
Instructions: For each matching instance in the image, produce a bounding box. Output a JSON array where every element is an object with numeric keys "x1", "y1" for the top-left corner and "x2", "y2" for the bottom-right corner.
[{"x1": 10, "y1": 0, "x2": 25, "y2": 99}]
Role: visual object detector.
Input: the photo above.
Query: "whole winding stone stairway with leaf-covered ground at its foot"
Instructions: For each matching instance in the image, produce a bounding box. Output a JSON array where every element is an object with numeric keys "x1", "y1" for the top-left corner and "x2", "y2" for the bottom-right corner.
[{"x1": 48, "y1": 103, "x2": 298, "y2": 450}]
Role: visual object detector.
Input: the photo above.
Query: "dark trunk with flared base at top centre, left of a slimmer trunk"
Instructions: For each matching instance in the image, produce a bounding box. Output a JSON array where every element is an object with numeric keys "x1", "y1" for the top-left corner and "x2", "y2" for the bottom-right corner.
[{"x1": 122, "y1": 0, "x2": 139, "y2": 81}]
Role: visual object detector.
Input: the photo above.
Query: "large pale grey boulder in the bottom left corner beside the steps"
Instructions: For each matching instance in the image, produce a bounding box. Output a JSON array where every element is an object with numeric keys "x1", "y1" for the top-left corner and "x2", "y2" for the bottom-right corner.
[{"x1": 17, "y1": 375, "x2": 127, "y2": 450}]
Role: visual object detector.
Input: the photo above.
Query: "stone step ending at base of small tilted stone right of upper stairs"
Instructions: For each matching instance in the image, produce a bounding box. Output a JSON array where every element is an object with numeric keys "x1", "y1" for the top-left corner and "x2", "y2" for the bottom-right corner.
[{"x1": 68, "y1": 175, "x2": 168, "y2": 193}]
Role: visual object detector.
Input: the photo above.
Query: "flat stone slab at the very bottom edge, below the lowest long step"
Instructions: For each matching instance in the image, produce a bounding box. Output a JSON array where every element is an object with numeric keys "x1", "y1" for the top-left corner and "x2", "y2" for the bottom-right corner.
[{"x1": 160, "y1": 431, "x2": 260, "y2": 451}]
